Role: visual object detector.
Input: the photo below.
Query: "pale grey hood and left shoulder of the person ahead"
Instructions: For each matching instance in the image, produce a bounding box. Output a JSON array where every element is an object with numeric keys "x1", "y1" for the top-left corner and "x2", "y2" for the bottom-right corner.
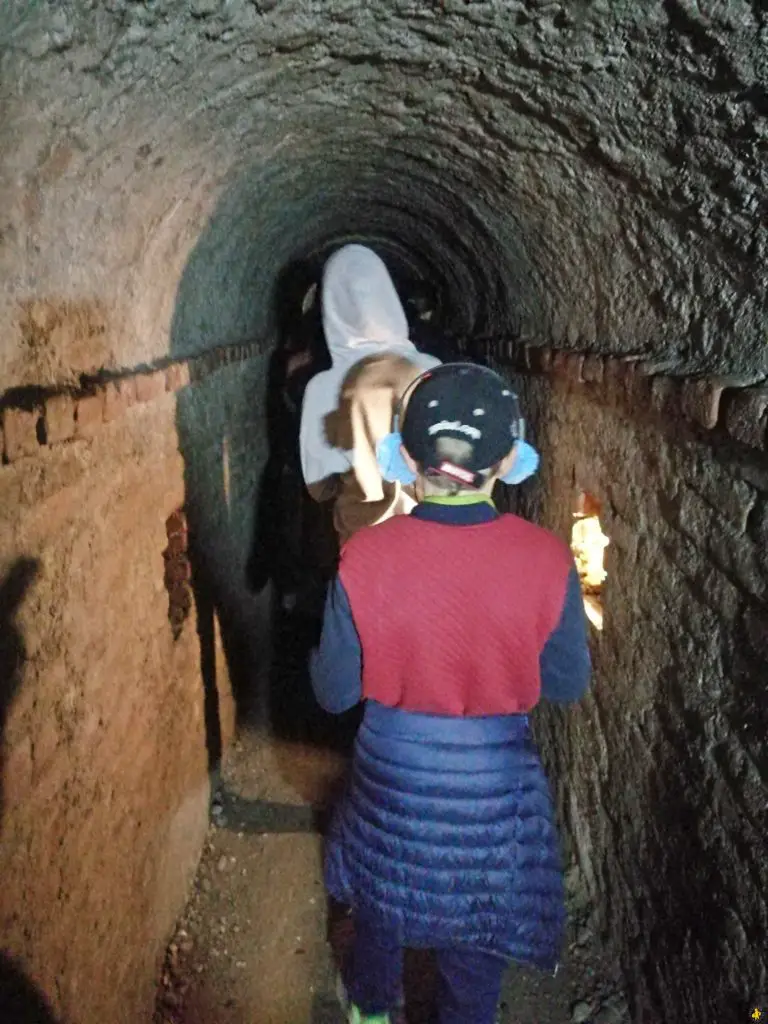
[{"x1": 300, "y1": 245, "x2": 439, "y2": 484}]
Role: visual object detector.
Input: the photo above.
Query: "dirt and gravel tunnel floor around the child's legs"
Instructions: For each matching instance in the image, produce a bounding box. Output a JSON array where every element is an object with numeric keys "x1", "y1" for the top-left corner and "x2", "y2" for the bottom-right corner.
[{"x1": 155, "y1": 606, "x2": 629, "y2": 1024}]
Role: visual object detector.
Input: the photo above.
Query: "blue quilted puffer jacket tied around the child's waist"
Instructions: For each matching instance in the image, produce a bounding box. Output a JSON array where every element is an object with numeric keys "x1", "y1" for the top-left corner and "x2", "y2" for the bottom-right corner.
[{"x1": 326, "y1": 701, "x2": 565, "y2": 971}]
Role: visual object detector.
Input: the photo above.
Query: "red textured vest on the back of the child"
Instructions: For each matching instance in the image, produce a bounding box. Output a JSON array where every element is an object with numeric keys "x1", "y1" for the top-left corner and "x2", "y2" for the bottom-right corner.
[{"x1": 339, "y1": 515, "x2": 572, "y2": 716}]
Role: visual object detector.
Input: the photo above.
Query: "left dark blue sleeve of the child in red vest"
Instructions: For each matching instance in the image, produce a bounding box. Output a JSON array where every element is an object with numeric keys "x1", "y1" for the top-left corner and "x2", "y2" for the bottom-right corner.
[{"x1": 309, "y1": 577, "x2": 362, "y2": 715}]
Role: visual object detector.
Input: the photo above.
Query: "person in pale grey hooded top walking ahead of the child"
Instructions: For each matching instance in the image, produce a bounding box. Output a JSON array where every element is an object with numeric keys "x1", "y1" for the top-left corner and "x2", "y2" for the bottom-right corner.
[{"x1": 299, "y1": 245, "x2": 440, "y2": 545}]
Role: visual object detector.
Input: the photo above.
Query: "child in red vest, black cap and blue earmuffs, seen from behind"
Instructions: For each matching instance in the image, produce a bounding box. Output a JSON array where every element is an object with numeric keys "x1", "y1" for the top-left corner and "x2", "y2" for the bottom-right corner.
[{"x1": 310, "y1": 364, "x2": 591, "y2": 1024}]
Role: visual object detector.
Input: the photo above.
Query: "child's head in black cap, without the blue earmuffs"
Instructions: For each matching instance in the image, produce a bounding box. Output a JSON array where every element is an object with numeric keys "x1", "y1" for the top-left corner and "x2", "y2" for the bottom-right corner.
[{"x1": 400, "y1": 362, "x2": 523, "y2": 496}]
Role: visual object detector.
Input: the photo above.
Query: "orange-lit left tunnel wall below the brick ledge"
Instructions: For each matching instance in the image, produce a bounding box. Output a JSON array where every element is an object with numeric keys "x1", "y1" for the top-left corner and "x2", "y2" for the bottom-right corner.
[{"x1": 0, "y1": 346, "x2": 260, "y2": 1024}]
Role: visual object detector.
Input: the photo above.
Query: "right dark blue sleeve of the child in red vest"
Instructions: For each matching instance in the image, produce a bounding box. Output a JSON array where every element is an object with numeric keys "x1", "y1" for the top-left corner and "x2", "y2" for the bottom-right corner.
[{"x1": 539, "y1": 565, "x2": 592, "y2": 703}]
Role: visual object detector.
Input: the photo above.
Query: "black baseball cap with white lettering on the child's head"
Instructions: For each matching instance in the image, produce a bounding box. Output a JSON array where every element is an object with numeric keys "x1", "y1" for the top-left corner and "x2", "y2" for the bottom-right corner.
[{"x1": 400, "y1": 362, "x2": 524, "y2": 486}]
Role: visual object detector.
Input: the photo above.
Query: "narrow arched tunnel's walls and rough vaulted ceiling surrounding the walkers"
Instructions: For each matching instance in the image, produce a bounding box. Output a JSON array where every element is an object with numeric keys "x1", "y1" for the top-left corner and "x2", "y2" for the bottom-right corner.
[{"x1": 0, "y1": 6, "x2": 768, "y2": 1024}]
